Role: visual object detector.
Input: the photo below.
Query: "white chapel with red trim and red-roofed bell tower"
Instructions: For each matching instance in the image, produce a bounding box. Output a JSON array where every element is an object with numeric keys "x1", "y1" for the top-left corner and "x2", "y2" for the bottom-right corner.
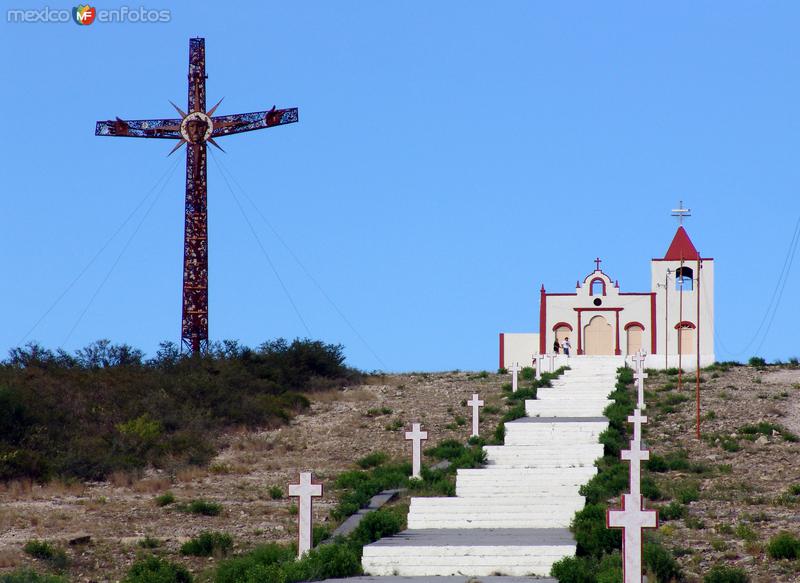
[{"x1": 500, "y1": 225, "x2": 715, "y2": 370}]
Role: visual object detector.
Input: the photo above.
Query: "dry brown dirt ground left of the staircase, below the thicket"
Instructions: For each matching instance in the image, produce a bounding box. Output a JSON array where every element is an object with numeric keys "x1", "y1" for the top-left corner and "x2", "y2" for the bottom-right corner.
[{"x1": 0, "y1": 372, "x2": 508, "y2": 582}]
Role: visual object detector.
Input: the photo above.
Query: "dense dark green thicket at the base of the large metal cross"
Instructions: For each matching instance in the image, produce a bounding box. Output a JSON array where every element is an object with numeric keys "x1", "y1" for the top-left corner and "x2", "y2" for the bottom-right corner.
[{"x1": 0, "y1": 340, "x2": 359, "y2": 480}]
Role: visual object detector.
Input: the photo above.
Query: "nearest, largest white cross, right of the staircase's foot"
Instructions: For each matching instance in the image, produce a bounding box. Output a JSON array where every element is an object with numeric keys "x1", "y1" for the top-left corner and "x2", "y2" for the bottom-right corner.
[{"x1": 606, "y1": 494, "x2": 658, "y2": 583}]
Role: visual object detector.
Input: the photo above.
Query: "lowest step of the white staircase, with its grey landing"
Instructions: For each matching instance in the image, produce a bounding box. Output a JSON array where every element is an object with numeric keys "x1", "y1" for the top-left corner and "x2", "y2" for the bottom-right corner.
[{"x1": 362, "y1": 528, "x2": 575, "y2": 577}]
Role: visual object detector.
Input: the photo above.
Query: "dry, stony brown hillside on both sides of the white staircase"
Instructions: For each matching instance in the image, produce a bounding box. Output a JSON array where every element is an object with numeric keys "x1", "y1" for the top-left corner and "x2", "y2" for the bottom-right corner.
[{"x1": 0, "y1": 366, "x2": 800, "y2": 583}]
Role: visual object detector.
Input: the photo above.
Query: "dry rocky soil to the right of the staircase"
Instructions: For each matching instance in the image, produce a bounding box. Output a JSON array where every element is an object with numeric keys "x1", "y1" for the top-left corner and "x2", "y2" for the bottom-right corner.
[{"x1": 645, "y1": 366, "x2": 800, "y2": 583}]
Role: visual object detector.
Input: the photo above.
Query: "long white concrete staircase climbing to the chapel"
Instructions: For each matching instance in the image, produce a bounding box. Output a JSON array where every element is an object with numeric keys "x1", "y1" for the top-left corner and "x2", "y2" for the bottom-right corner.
[{"x1": 362, "y1": 357, "x2": 624, "y2": 577}]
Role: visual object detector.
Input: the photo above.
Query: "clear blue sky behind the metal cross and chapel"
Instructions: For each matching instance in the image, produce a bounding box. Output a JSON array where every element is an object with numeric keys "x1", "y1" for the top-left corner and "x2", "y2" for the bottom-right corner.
[{"x1": 0, "y1": 0, "x2": 800, "y2": 370}]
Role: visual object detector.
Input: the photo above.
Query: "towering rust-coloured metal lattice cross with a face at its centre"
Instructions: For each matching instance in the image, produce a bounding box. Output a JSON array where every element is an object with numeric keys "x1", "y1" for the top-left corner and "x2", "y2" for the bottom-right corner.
[{"x1": 95, "y1": 38, "x2": 298, "y2": 353}]
